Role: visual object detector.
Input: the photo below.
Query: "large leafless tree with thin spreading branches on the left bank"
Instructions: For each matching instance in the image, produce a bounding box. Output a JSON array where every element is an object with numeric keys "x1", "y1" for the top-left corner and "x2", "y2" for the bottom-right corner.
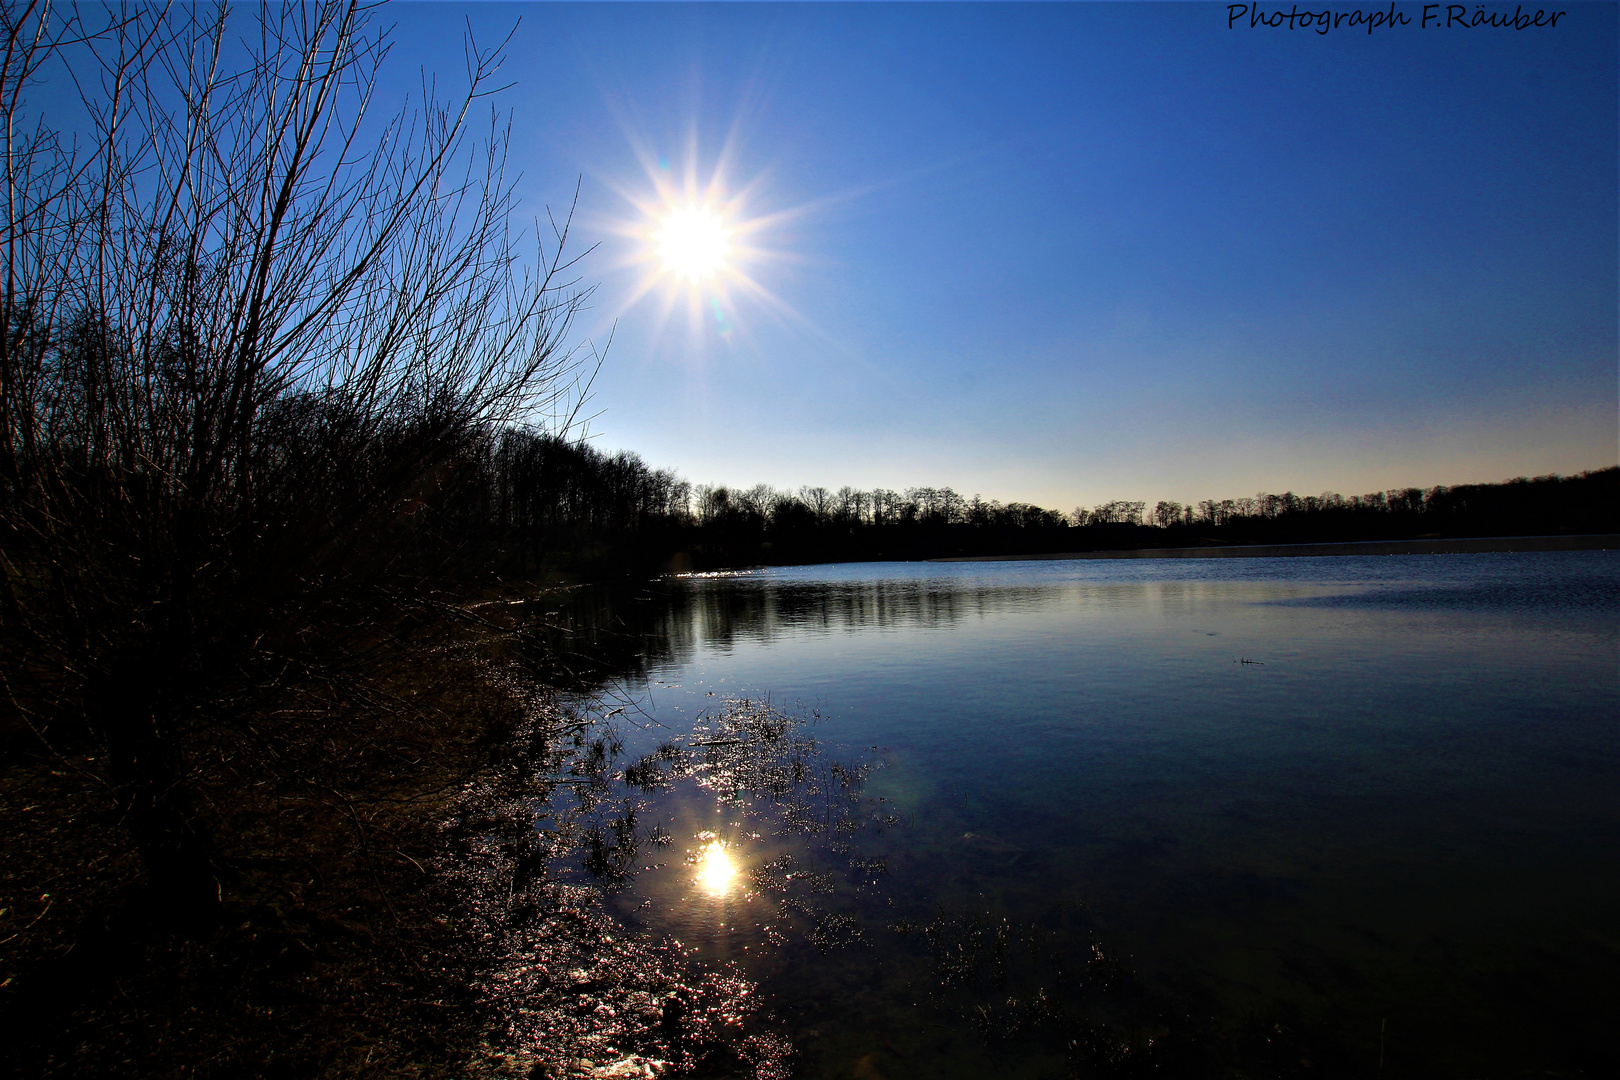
[{"x1": 0, "y1": 0, "x2": 591, "y2": 895}]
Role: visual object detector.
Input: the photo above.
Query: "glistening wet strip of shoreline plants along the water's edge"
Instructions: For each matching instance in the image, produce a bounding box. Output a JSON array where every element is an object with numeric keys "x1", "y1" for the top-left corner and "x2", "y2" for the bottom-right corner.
[{"x1": 442, "y1": 701, "x2": 792, "y2": 1080}]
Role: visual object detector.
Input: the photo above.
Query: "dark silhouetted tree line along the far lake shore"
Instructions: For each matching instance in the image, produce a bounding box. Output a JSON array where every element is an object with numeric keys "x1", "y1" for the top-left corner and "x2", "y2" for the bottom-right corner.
[{"x1": 463, "y1": 429, "x2": 1620, "y2": 575}]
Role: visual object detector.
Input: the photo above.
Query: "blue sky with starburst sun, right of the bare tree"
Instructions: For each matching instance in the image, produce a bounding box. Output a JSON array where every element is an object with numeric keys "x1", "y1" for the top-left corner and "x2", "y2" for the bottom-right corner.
[{"x1": 382, "y1": 3, "x2": 1620, "y2": 510}]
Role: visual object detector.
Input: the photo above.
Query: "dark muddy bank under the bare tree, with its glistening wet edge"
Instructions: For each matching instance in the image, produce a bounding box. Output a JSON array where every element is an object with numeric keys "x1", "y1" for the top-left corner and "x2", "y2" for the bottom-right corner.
[{"x1": 0, "y1": 641, "x2": 791, "y2": 1078}]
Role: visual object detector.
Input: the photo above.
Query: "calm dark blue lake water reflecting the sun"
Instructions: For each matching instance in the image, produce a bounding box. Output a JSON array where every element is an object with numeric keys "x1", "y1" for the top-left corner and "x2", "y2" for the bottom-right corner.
[{"x1": 554, "y1": 552, "x2": 1620, "y2": 1078}]
